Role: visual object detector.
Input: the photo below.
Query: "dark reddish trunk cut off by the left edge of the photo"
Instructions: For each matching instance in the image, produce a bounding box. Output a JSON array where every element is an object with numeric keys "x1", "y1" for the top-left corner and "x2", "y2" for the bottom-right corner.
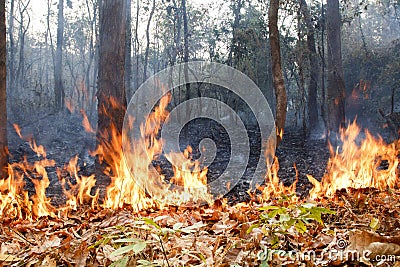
[{"x1": 0, "y1": 0, "x2": 8, "y2": 178}]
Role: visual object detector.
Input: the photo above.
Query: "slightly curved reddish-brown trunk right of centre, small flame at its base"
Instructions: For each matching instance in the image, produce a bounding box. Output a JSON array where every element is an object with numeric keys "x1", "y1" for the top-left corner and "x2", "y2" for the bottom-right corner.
[{"x1": 268, "y1": 0, "x2": 287, "y2": 144}]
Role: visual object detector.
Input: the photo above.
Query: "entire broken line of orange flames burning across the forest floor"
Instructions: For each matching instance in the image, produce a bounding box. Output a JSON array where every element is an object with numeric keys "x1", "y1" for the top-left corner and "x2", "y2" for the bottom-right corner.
[{"x1": 0, "y1": 94, "x2": 400, "y2": 220}]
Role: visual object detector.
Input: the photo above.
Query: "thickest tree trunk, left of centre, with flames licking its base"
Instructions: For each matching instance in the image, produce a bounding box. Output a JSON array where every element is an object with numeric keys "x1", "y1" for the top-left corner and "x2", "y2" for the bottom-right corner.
[{"x1": 97, "y1": 0, "x2": 126, "y2": 153}]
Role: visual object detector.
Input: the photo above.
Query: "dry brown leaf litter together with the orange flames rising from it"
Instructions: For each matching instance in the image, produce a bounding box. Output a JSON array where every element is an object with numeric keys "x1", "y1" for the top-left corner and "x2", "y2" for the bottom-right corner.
[{"x1": 0, "y1": 98, "x2": 400, "y2": 266}]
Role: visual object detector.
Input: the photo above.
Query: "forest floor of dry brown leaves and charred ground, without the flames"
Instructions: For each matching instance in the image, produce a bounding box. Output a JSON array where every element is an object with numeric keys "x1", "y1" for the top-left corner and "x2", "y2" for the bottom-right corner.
[{"x1": 0, "y1": 110, "x2": 400, "y2": 266}]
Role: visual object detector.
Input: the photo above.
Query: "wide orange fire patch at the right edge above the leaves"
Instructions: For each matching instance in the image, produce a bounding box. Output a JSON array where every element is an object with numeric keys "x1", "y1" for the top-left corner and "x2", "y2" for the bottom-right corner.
[{"x1": 308, "y1": 121, "x2": 399, "y2": 198}]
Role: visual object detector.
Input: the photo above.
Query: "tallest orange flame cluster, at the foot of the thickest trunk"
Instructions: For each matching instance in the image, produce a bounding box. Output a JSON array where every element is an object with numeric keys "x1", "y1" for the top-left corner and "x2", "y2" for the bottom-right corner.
[{"x1": 100, "y1": 94, "x2": 212, "y2": 210}]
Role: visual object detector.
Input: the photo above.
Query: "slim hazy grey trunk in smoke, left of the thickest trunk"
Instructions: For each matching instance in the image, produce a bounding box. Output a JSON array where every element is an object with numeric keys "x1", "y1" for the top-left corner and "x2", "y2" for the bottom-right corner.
[{"x1": 54, "y1": 0, "x2": 64, "y2": 111}]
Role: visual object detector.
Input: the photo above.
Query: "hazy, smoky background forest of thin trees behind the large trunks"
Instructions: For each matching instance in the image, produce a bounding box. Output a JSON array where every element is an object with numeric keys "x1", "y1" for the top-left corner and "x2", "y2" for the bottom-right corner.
[{"x1": 6, "y1": 0, "x2": 400, "y2": 138}]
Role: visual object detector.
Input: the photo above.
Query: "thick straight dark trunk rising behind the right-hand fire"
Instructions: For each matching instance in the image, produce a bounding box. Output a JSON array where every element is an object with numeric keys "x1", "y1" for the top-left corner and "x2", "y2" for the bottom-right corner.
[{"x1": 326, "y1": 0, "x2": 345, "y2": 133}]
